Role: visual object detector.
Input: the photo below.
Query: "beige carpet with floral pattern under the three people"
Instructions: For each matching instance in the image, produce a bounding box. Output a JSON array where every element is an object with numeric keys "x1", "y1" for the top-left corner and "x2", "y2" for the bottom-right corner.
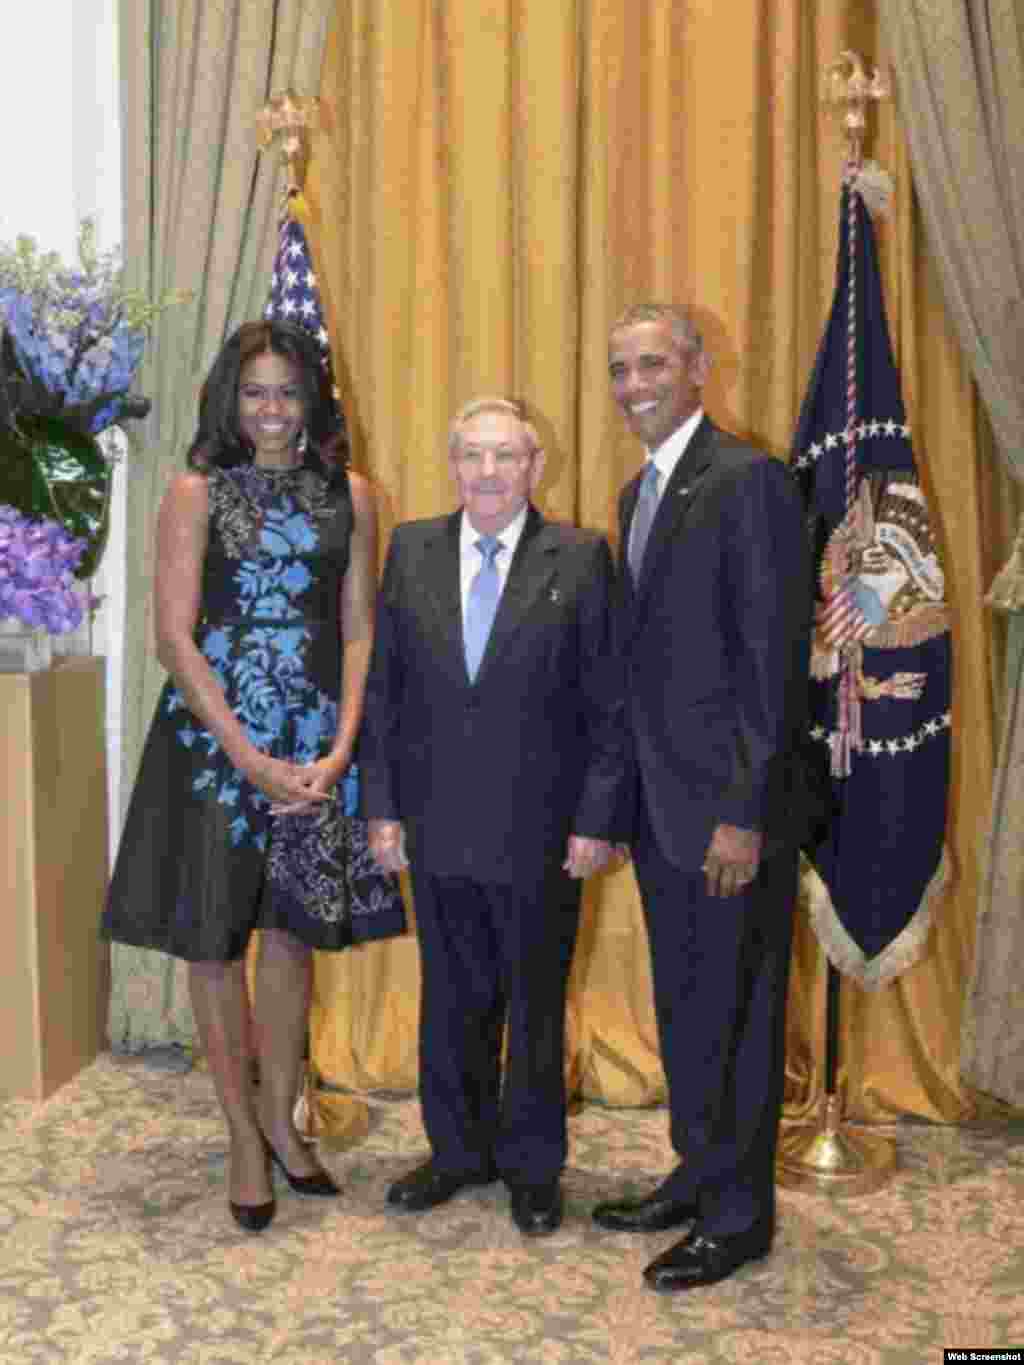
[{"x1": 0, "y1": 1057, "x2": 1024, "y2": 1365}]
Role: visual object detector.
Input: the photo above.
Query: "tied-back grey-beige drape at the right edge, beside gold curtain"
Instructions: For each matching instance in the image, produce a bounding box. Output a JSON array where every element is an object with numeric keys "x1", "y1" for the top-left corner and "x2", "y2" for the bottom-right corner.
[{"x1": 883, "y1": 0, "x2": 1024, "y2": 1106}]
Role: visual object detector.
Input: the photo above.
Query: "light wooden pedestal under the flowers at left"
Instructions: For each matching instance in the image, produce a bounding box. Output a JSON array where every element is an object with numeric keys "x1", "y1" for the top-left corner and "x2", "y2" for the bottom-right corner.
[{"x1": 0, "y1": 658, "x2": 106, "y2": 1100}]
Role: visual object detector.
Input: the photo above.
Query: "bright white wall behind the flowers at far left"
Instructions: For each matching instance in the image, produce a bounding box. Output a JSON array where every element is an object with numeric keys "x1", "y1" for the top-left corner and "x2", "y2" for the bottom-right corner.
[{"x1": 0, "y1": 0, "x2": 127, "y2": 850}]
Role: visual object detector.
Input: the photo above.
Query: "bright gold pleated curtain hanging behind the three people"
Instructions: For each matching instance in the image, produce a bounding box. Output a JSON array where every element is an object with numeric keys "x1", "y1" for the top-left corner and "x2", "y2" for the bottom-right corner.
[{"x1": 306, "y1": 0, "x2": 1005, "y2": 1121}]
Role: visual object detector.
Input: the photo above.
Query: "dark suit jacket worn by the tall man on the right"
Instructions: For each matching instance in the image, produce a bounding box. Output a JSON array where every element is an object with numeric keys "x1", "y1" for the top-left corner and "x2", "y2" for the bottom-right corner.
[{"x1": 618, "y1": 418, "x2": 812, "y2": 871}]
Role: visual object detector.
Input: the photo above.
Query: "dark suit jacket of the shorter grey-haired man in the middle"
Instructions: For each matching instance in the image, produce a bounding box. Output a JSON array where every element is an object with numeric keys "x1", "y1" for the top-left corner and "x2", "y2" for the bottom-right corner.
[{"x1": 359, "y1": 506, "x2": 628, "y2": 883}]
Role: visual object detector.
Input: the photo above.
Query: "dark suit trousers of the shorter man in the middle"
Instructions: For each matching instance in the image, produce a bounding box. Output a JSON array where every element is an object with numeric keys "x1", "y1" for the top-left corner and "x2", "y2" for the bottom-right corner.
[{"x1": 411, "y1": 857, "x2": 580, "y2": 1185}]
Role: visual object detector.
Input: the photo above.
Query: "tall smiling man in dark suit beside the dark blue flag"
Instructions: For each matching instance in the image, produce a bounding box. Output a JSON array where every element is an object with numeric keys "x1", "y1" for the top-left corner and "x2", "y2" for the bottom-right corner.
[{"x1": 594, "y1": 304, "x2": 811, "y2": 1290}]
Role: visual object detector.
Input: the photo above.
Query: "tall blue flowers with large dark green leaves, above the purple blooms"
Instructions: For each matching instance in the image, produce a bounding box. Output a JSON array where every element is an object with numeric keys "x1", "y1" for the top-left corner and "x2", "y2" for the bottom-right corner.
[{"x1": 0, "y1": 218, "x2": 190, "y2": 606}]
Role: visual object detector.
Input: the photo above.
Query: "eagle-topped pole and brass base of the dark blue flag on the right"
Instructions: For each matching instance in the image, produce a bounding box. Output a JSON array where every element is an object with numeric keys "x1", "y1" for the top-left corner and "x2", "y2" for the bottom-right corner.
[{"x1": 776, "y1": 52, "x2": 896, "y2": 1196}]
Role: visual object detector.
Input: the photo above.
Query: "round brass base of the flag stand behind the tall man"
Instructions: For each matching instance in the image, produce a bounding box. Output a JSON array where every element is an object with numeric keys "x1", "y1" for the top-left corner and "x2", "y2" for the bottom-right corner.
[{"x1": 776, "y1": 1095, "x2": 896, "y2": 1196}]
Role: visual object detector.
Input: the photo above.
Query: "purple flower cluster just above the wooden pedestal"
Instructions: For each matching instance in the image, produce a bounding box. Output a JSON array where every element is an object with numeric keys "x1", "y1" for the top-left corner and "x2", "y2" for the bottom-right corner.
[{"x1": 0, "y1": 504, "x2": 86, "y2": 635}]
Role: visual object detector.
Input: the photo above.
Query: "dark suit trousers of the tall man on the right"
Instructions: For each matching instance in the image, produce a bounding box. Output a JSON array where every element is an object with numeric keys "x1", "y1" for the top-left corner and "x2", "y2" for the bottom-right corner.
[{"x1": 632, "y1": 799, "x2": 797, "y2": 1235}]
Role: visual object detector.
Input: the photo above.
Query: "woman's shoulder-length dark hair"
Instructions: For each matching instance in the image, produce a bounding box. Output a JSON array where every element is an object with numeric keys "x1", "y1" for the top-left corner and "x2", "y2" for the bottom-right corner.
[{"x1": 187, "y1": 321, "x2": 348, "y2": 478}]
